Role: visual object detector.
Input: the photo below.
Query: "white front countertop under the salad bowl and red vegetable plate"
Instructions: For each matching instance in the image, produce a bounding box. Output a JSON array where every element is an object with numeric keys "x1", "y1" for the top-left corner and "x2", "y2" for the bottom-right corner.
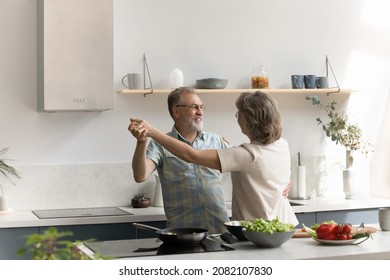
[{"x1": 80, "y1": 224, "x2": 390, "y2": 260}]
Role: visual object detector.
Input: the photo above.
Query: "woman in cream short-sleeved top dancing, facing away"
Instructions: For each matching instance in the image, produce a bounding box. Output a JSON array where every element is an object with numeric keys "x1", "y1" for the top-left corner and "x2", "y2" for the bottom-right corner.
[{"x1": 129, "y1": 91, "x2": 298, "y2": 225}]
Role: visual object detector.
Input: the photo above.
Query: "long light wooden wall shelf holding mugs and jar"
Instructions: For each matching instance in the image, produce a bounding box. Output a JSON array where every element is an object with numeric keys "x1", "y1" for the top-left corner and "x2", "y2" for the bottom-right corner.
[{"x1": 117, "y1": 88, "x2": 352, "y2": 95}]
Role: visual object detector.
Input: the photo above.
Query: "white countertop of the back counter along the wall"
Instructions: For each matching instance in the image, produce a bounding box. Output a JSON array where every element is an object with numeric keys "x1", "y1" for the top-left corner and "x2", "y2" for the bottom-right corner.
[{"x1": 0, "y1": 198, "x2": 390, "y2": 229}]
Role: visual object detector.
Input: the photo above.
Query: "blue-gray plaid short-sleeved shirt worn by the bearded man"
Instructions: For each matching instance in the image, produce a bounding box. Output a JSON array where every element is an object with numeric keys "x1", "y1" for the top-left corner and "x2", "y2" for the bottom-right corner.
[{"x1": 146, "y1": 128, "x2": 229, "y2": 233}]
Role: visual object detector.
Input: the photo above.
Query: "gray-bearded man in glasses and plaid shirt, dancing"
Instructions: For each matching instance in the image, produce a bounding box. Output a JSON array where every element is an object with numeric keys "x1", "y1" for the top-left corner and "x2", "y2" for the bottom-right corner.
[{"x1": 129, "y1": 87, "x2": 229, "y2": 233}]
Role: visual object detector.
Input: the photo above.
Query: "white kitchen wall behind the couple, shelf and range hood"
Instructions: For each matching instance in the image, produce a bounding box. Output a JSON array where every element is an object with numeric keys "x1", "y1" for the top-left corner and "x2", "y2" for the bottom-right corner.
[{"x1": 0, "y1": 0, "x2": 390, "y2": 209}]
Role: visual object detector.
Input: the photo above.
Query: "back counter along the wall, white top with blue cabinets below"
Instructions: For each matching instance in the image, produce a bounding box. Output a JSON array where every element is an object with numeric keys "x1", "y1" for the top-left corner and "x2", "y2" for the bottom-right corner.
[{"x1": 0, "y1": 197, "x2": 390, "y2": 259}]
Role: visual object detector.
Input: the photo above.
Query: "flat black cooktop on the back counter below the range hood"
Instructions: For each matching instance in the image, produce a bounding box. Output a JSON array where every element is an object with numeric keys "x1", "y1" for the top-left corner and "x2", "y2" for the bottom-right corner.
[{"x1": 32, "y1": 207, "x2": 133, "y2": 219}]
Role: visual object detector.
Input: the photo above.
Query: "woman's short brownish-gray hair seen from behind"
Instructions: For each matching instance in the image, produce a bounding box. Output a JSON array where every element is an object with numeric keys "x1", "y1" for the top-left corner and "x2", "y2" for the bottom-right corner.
[{"x1": 236, "y1": 91, "x2": 282, "y2": 145}]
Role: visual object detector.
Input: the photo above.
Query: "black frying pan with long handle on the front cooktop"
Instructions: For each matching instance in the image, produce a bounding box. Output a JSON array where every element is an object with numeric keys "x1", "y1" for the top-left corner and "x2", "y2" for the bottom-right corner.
[{"x1": 133, "y1": 223, "x2": 208, "y2": 245}]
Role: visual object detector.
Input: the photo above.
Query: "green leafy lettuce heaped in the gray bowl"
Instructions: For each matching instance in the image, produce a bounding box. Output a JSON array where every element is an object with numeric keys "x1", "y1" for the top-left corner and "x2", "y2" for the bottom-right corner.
[{"x1": 241, "y1": 217, "x2": 295, "y2": 233}]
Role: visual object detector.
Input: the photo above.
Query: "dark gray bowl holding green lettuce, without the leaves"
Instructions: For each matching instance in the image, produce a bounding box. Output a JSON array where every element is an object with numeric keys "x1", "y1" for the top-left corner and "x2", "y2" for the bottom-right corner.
[{"x1": 243, "y1": 228, "x2": 295, "y2": 248}]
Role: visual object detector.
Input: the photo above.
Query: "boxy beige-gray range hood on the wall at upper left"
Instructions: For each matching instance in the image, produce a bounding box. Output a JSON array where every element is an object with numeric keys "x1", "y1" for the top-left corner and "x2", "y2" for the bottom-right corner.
[{"x1": 37, "y1": 0, "x2": 114, "y2": 112}]
